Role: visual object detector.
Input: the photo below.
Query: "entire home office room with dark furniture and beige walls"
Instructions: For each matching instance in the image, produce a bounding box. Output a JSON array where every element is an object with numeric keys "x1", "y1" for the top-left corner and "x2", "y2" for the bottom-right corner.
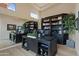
[{"x1": 0, "y1": 3, "x2": 79, "y2": 56}]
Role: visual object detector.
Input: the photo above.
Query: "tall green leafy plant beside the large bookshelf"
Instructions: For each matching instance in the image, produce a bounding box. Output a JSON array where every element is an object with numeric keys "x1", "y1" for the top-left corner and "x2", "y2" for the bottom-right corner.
[{"x1": 64, "y1": 14, "x2": 76, "y2": 34}]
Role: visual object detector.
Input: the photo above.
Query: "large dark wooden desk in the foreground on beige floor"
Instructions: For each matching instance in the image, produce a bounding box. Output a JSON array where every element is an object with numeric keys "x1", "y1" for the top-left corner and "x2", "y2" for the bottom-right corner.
[{"x1": 22, "y1": 37, "x2": 57, "y2": 56}]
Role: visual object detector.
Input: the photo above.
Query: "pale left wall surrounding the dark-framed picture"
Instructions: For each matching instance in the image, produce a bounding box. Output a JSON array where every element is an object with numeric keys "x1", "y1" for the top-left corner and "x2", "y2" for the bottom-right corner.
[{"x1": 0, "y1": 14, "x2": 25, "y2": 39}]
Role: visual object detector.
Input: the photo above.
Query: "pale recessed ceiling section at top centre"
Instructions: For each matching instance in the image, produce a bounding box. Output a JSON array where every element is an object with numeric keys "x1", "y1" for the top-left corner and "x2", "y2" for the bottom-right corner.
[{"x1": 32, "y1": 3, "x2": 56, "y2": 11}]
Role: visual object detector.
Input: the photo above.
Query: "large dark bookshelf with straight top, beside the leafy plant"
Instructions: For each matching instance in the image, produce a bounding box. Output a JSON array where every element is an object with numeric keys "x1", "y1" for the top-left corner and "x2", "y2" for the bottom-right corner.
[{"x1": 41, "y1": 13, "x2": 68, "y2": 44}]
